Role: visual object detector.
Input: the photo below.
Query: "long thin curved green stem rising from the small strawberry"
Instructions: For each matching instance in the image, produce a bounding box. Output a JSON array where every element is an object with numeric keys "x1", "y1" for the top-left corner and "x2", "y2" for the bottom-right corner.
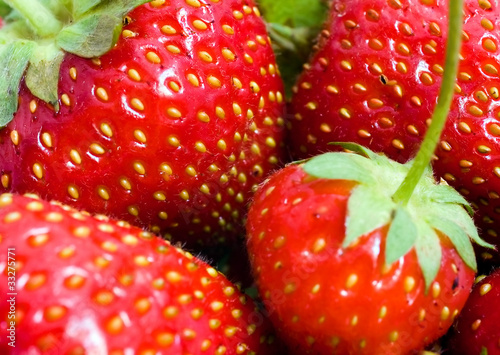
[{"x1": 393, "y1": 0, "x2": 463, "y2": 205}]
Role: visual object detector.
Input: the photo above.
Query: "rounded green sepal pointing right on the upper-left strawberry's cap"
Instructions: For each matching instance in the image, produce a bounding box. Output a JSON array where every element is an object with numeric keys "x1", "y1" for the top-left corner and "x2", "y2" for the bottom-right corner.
[{"x1": 56, "y1": 14, "x2": 122, "y2": 58}]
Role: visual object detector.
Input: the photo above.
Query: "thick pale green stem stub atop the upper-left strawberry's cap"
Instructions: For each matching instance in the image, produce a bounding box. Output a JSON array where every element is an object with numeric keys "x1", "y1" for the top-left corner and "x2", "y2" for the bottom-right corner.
[{"x1": 4, "y1": 0, "x2": 62, "y2": 38}]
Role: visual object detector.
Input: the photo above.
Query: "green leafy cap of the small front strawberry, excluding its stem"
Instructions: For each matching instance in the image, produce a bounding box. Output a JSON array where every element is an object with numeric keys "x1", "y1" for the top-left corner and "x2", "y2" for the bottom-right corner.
[{"x1": 303, "y1": 143, "x2": 493, "y2": 289}]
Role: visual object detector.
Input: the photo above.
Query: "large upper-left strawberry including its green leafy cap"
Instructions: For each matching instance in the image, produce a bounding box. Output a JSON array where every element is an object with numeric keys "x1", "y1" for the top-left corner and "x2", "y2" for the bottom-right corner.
[{"x1": 0, "y1": 0, "x2": 284, "y2": 247}]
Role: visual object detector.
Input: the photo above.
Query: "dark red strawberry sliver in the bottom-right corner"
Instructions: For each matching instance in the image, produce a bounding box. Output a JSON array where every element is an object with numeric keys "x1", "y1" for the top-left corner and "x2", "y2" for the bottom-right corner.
[{"x1": 447, "y1": 269, "x2": 500, "y2": 355}]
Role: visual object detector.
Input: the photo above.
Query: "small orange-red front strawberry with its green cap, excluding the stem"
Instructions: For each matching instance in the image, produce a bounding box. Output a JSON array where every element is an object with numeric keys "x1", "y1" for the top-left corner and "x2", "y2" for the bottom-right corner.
[{"x1": 247, "y1": 153, "x2": 488, "y2": 355}]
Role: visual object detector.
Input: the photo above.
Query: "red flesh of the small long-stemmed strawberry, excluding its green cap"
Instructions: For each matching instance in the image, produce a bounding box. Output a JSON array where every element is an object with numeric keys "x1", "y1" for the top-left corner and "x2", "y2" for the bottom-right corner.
[{"x1": 247, "y1": 165, "x2": 474, "y2": 355}]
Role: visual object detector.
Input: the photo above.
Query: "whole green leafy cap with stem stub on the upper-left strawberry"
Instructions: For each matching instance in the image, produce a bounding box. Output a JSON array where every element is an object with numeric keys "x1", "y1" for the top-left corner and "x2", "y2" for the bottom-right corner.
[{"x1": 0, "y1": 0, "x2": 148, "y2": 127}]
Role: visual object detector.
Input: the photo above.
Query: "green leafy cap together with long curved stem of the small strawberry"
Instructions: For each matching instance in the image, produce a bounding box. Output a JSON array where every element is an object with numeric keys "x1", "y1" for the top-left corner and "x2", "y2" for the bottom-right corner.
[{"x1": 304, "y1": 0, "x2": 493, "y2": 289}]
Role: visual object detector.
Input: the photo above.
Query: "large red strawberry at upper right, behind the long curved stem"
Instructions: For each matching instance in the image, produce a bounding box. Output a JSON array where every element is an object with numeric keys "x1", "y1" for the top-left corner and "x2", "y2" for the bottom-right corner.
[{"x1": 289, "y1": 0, "x2": 500, "y2": 268}]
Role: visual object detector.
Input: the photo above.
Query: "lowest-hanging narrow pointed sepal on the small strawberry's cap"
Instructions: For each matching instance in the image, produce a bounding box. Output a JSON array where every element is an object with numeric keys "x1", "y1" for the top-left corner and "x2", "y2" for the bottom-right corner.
[{"x1": 415, "y1": 223, "x2": 442, "y2": 292}]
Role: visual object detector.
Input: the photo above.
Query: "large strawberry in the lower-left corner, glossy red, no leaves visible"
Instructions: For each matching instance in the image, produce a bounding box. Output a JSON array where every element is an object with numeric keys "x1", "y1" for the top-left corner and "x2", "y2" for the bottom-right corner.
[{"x1": 0, "y1": 194, "x2": 282, "y2": 355}]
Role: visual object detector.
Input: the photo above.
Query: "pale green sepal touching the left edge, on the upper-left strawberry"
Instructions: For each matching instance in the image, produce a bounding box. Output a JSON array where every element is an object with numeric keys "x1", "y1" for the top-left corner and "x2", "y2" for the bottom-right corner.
[{"x1": 0, "y1": 41, "x2": 36, "y2": 127}]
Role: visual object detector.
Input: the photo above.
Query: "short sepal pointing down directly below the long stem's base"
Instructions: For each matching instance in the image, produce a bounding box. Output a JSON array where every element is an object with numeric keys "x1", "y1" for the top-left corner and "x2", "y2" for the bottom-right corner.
[{"x1": 385, "y1": 206, "x2": 418, "y2": 265}]
